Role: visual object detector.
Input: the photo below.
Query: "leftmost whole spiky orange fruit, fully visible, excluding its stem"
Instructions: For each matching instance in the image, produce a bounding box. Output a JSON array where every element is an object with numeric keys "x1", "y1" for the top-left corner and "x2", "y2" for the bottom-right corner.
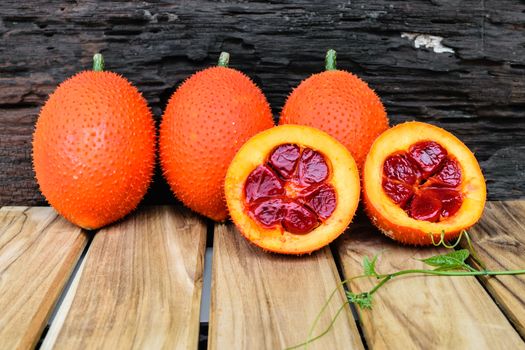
[{"x1": 33, "y1": 71, "x2": 156, "y2": 229}]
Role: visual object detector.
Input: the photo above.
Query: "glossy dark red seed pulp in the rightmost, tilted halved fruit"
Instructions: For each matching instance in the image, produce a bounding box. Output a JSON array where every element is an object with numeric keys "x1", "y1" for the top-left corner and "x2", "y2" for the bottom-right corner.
[{"x1": 383, "y1": 141, "x2": 463, "y2": 222}]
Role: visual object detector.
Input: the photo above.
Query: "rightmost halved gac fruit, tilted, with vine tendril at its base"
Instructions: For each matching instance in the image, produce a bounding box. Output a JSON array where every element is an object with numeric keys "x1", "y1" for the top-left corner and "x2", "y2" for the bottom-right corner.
[{"x1": 363, "y1": 122, "x2": 486, "y2": 245}]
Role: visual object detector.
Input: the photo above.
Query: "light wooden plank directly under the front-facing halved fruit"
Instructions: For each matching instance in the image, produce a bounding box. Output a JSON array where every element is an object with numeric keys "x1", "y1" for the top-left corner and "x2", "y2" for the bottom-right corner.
[{"x1": 208, "y1": 224, "x2": 363, "y2": 349}]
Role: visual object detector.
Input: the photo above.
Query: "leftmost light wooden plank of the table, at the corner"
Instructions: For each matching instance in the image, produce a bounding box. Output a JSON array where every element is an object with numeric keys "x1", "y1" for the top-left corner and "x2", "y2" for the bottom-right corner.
[{"x1": 0, "y1": 207, "x2": 88, "y2": 349}]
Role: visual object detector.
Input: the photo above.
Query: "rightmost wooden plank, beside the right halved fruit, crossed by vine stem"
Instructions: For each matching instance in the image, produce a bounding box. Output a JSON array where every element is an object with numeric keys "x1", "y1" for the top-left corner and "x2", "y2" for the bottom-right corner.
[{"x1": 462, "y1": 200, "x2": 525, "y2": 338}]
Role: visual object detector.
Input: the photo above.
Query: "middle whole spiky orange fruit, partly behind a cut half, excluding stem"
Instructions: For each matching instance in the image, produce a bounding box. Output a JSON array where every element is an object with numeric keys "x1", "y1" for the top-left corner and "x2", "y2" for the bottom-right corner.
[{"x1": 159, "y1": 67, "x2": 274, "y2": 221}]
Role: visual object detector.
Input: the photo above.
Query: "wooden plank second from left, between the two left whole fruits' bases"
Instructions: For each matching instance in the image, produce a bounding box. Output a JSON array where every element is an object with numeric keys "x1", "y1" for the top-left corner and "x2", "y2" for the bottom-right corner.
[{"x1": 44, "y1": 207, "x2": 206, "y2": 349}]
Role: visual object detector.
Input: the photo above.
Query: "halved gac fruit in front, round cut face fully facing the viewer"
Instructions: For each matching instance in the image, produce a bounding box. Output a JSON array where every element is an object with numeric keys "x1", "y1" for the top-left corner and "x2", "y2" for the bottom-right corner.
[{"x1": 225, "y1": 125, "x2": 360, "y2": 254}]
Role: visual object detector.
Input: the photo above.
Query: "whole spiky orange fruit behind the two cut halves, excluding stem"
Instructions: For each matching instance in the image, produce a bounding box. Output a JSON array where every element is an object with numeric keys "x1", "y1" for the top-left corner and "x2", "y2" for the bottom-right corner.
[{"x1": 279, "y1": 70, "x2": 388, "y2": 168}]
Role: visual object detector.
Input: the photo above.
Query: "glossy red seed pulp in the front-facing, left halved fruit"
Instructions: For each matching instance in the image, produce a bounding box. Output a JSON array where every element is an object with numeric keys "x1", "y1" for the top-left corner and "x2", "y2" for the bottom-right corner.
[{"x1": 244, "y1": 144, "x2": 337, "y2": 234}]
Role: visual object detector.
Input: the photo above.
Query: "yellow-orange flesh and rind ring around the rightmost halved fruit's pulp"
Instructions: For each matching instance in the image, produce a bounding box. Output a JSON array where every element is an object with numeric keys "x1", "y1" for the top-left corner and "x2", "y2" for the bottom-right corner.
[{"x1": 362, "y1": 122, "x2": 487, "y2": 246}]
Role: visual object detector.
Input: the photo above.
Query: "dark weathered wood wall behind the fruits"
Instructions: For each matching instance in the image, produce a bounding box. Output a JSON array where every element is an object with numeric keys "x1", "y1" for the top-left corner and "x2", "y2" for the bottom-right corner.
[{"x1": 0, "y1": 0, "x2": 525, "y2": 205}]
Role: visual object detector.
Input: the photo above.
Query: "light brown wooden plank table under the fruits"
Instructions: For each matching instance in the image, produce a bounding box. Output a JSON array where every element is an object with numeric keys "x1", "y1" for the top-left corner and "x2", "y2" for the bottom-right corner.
[{"x1": 0, "y1": 201, "x2": 525, "y2": 350}]
